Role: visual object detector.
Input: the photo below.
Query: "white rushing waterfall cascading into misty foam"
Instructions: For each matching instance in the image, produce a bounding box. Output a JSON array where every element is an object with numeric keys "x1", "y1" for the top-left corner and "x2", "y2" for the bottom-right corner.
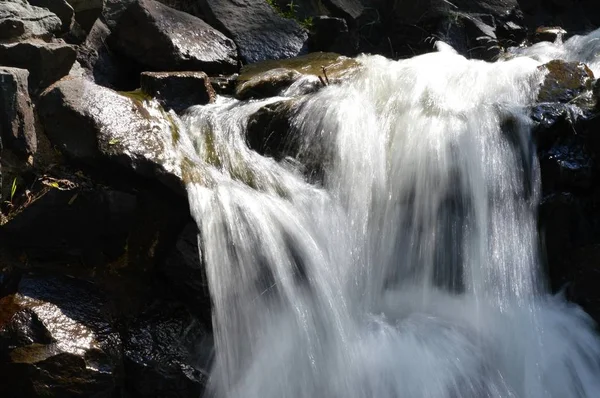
[{"x1": 179, "y1": 33, "x2": 600, "y2": 398}]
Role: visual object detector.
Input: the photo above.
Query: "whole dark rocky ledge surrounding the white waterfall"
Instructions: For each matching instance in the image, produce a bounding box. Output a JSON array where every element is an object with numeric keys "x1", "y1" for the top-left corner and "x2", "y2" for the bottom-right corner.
[{"x1": 0, "y1": 0, "x2": 600, "y2": 397}]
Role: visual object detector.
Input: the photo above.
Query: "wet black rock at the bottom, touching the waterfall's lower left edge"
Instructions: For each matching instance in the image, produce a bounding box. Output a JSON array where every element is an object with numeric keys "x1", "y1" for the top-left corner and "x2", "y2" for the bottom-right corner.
[{"x1": 124, "y1": 303, "x2": 213, "y2": 398}]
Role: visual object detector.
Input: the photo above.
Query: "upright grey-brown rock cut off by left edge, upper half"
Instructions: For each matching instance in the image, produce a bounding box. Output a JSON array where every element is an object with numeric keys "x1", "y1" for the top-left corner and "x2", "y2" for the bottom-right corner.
[{"x1": 0, "y1": 67, "x2": 37, "y2": 155}]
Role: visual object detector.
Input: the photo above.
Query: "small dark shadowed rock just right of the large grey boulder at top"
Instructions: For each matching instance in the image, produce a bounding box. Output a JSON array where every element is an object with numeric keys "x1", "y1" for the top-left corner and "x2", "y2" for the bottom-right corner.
[{"x1": 309, "y1": 15, "x2": 358, "y2": 55}]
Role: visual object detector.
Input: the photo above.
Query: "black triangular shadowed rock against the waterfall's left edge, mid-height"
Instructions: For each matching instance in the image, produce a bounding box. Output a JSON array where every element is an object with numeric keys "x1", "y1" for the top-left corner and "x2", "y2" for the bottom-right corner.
[{"x1": 160, "y1": 221, "x2": 211, "y2": 318}]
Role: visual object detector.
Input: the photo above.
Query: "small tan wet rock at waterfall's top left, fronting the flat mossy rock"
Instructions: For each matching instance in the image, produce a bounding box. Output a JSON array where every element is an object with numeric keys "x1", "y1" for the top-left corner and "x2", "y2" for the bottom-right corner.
[{"x1": 235, "y1": 68, "x2": 302, "y2": 100}]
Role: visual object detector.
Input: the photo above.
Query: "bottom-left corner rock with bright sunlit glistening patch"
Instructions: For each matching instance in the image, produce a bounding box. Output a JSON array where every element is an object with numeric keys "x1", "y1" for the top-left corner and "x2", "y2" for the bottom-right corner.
[{"x1": 0, "y1": 275, "x2": 122, "y2": 398}]
